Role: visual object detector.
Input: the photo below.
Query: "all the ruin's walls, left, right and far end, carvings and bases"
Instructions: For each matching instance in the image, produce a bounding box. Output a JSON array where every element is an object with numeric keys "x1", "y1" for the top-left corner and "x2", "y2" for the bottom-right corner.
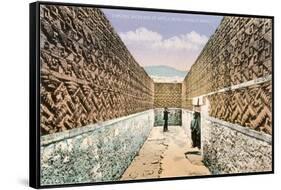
[{"x1": 40, "y1": 5, "x2": 272, "y2": 185}]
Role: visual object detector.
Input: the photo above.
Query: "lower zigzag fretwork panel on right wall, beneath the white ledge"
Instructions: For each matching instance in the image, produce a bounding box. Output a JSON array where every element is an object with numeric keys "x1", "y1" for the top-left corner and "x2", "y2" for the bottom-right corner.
[{"x1": 207, "y1": 82, "x2": 272, "y2": 134}]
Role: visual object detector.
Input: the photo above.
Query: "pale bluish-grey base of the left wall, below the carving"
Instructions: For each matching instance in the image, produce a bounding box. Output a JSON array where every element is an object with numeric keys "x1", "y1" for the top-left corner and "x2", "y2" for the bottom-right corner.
[{"x1": 41, "y1": 110, "x2": 154, "y2": 185}]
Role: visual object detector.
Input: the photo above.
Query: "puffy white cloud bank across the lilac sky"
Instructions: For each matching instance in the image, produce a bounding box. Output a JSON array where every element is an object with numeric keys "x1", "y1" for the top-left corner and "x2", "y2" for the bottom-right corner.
[{"x1": 120, "y1": 27, "x2": 208, "y2": 51}]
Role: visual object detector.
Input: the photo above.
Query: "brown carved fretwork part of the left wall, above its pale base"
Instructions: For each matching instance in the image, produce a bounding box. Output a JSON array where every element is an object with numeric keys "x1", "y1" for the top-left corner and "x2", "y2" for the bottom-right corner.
[{"x1": 40, "y1": 5, "x2": 154, "y2": 135}]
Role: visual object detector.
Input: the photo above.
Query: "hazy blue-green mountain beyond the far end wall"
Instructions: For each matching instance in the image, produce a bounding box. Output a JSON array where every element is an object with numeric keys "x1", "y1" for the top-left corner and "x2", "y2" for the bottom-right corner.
[{"x1": 144, "y1": 65, "x2": 187, "y2": 78}]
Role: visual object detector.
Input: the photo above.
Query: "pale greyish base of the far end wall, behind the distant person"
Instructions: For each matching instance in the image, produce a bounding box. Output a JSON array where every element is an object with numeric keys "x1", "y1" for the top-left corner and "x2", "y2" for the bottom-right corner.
[{"x1": 154, "y1": 108, "x2": 182, "y2": 126}]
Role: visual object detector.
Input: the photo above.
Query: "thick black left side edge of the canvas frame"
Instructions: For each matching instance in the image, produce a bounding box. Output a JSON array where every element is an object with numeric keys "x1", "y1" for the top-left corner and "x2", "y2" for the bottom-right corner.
[{"x1": 29, "y1": 2, "x2": 40, "y2": 188}]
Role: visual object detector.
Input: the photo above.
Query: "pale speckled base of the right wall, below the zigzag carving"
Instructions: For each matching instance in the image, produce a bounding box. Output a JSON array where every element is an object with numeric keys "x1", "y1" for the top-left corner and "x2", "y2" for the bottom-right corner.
[{"x1": 202, "y1": 117, "x2": 272, "y2": 174}]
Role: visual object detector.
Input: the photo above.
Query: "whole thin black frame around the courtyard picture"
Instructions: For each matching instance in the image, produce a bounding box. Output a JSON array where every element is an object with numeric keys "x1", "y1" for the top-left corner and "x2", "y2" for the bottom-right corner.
[{"x1": 29, "y1": 1, "x2": 274, "y2": 188}]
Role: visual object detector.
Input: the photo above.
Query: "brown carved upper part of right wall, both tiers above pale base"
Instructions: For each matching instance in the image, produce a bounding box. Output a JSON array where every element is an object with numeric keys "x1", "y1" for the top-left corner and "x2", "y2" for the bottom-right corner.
[{"x1": 182, "y1": 16, "x2": 272, "y2": 134}]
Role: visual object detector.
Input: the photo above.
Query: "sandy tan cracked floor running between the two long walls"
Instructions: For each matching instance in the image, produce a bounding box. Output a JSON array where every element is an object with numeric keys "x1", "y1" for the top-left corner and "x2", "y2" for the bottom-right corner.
[{"x1": 121, "y1": 126, "x2": 210, "y2": 180}]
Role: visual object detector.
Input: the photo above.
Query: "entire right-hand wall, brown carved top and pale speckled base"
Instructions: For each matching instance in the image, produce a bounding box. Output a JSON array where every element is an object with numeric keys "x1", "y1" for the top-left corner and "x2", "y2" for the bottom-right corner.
[{"x1": 182, "y1": 17, "x2": 272, "y2": 174}]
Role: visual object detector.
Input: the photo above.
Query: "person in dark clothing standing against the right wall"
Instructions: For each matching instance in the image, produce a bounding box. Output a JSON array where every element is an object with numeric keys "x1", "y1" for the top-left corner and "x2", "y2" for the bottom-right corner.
[{"x1": 190, "y1": 112, "x2": 201, "y2": 149}]
